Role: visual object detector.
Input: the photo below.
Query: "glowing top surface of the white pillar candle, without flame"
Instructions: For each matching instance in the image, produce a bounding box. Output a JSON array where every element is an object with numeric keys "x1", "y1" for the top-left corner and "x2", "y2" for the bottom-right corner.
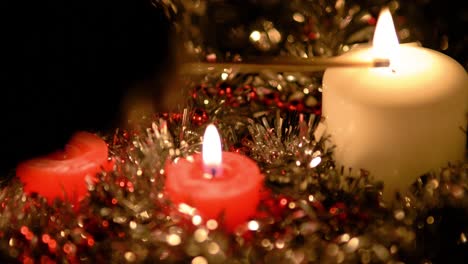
[{"x1": 323, "y1": 45, "x2": 468, "y2": 107}]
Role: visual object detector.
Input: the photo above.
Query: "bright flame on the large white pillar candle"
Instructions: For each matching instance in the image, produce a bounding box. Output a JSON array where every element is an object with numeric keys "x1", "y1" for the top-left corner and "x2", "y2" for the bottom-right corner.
[{"x1": 372, "y1": 8, "x2": 400, "y2": 68}]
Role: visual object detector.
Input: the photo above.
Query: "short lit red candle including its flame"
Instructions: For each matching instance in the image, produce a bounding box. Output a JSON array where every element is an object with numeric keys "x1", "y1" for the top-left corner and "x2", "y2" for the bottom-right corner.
[{"x1": 165, "y1": 125, "x2": 263, "y2": 231}]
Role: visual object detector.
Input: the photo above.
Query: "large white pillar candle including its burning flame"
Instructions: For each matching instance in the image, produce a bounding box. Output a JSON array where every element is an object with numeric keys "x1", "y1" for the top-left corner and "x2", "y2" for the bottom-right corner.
[{"x1": 323, "y1": 9, "x2": 468, "y2": 197}]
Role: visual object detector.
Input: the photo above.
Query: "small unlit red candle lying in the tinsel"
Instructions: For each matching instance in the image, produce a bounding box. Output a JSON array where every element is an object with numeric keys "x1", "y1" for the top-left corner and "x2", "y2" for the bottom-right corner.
[{"x1": 16, "y1": 132, "x2": 112, "y2": 205}]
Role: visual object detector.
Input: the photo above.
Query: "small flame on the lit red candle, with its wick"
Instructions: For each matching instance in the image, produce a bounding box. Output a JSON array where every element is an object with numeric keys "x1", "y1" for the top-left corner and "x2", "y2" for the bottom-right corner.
[{"x1": 202, "y1": 124, "x2": 222, "y2": 178}]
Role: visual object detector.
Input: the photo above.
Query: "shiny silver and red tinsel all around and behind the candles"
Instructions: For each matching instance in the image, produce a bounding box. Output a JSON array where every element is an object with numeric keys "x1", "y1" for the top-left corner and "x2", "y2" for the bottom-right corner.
[{"x1": 0, "y1": 0, "x2": 468, "y2": 264}]
